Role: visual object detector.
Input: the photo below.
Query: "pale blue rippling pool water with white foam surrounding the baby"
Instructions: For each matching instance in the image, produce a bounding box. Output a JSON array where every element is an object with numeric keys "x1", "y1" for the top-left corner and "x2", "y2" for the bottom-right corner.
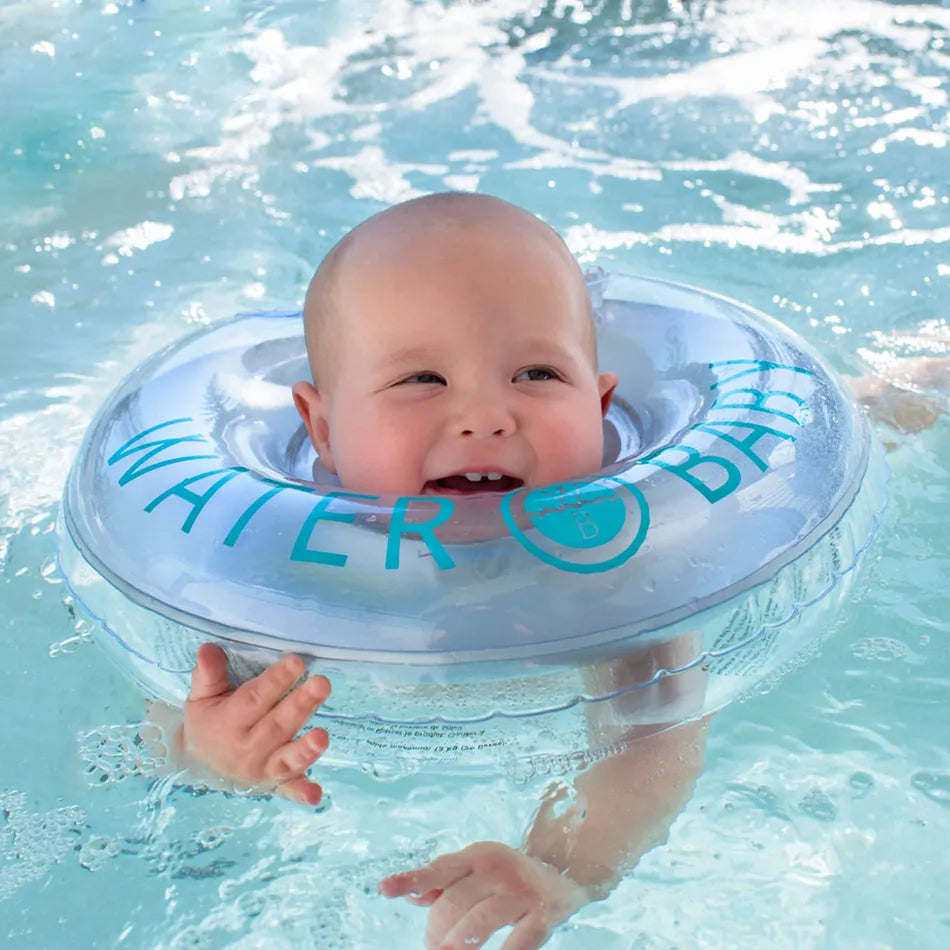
[{"x1": 0, "y1": 0, "x2": 950, "y2": 950}]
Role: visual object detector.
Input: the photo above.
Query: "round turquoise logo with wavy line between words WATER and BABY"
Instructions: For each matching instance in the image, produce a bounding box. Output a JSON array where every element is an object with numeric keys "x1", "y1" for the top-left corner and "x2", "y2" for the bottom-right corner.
[{"x1": 501, "y1": 476, "x2": 650, "y2": 574}]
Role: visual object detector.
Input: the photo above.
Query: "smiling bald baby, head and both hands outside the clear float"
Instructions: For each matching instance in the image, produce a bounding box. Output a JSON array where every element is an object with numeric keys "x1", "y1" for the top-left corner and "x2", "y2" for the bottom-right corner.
[{"x1": 180, "y1": 193, "x2": 705, "y2": 950}]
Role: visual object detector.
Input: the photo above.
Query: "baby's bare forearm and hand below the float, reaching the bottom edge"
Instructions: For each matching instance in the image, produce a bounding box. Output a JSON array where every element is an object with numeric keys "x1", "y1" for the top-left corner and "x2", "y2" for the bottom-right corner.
[{"x1": 380, "y1": 720, "x2": 708, "y2": 950}]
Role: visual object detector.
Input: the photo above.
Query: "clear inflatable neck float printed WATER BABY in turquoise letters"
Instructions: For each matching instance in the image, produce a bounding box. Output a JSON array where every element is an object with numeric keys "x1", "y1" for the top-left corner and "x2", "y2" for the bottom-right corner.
[{"x1": 59, "y1": 271, "x2": 885, "y2": 777}]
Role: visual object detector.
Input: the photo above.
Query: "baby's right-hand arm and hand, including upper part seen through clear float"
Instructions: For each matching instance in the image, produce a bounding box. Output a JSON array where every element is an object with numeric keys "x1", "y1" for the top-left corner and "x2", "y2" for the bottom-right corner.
[{"x1": 380, "y1": 634, "x2": 708, "y2": 950}]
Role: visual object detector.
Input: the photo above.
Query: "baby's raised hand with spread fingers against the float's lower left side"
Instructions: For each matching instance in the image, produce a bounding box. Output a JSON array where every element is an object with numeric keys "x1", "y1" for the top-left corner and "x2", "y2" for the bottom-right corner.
[{"x1": 181, "y1": 643, "x2": 330, "y2": 805}]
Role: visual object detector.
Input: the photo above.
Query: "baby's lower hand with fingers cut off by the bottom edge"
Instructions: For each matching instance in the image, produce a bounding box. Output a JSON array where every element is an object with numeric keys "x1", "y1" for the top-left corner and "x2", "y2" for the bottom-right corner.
[{"x1": 379, "y1": 841, "x2": 590, "y2": 950}]
